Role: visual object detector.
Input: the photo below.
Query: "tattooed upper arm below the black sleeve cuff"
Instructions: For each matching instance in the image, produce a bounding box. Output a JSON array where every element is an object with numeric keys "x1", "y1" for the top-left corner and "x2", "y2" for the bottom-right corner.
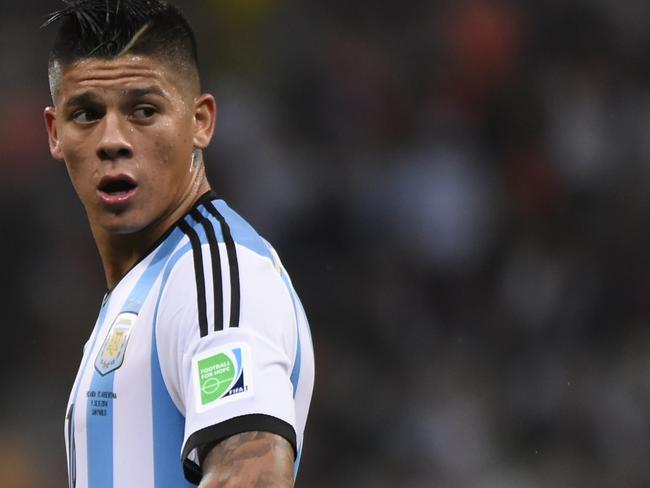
[{"x1": 199, "y1": 432, "x2": 294, "y2": 488}]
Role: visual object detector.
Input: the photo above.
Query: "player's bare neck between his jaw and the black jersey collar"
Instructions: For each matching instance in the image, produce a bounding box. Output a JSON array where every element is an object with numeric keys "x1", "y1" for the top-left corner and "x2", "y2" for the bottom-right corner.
[{"x1": 91, "y1": 171, "x2": 210, "y2": 289}]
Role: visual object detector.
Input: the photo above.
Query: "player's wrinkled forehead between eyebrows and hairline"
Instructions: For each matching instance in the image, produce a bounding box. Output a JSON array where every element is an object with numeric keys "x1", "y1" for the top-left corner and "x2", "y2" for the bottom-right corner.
[{"x1": 57, "y1": 55, "x2": 182, "y2": 101}]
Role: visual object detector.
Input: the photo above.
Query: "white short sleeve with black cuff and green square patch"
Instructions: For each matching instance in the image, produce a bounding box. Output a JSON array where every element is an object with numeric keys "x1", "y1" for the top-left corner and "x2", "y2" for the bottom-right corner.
[{"x1": 156, "y1": 246, "x2": 297, "y2": 483}]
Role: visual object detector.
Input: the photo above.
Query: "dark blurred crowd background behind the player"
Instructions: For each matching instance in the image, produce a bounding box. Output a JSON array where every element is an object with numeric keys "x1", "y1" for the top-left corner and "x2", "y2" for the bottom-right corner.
[{"x1": 0, "y1": 0, "x2": 650, "y2": 488}]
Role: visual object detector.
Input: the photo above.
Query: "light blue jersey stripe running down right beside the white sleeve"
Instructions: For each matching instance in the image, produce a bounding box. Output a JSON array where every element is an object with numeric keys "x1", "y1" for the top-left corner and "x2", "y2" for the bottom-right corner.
[{"x1": 151, "y1": 240, "x2": 194, "y2": 488}]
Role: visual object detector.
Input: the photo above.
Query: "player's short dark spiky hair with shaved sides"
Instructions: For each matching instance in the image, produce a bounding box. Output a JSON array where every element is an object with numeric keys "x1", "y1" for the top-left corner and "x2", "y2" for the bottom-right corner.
[{"x1": 42, "y1": 0, "x2": 199, "y2": 97}]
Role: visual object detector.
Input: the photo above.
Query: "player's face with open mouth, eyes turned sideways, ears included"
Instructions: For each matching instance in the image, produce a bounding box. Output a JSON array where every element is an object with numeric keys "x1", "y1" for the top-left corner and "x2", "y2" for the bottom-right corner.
[{"x1": 45, "y1": 55, "x2": 214, "y2": 234}]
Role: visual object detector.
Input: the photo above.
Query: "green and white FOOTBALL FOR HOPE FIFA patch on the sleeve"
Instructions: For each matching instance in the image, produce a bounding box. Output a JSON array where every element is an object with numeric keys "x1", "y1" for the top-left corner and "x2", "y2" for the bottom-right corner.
[{"x1": 192, "y1": 344, "x2": 253, "y2": 412}]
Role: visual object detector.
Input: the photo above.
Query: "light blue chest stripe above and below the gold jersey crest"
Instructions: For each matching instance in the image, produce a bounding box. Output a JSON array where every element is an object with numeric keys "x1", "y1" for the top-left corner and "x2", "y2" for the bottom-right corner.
[{"x1": 86, "y1": 228, "x2": 183, "y2": 488}]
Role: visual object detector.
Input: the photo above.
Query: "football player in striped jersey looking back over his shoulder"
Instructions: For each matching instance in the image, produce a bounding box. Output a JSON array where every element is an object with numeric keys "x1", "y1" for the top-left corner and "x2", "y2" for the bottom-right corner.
[{"x1": 45, "y1": 0, "x2": 314, "y2": 488}]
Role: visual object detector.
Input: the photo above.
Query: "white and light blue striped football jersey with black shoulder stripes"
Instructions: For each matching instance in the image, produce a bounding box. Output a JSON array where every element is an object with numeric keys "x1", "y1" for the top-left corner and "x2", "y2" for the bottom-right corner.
[{"x1": 65, "y1": 192, "x2": 314, "y2": 488}]
